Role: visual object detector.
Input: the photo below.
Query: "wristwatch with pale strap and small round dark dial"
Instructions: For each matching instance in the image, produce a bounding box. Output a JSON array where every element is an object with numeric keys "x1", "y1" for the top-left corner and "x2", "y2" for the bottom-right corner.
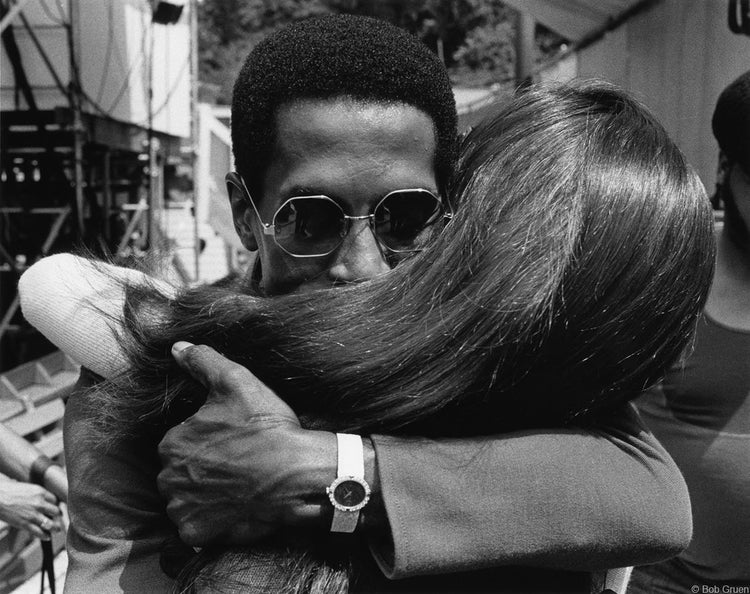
[{"x1": 326, "y1": 433, "x2": 370, "y2": 532}]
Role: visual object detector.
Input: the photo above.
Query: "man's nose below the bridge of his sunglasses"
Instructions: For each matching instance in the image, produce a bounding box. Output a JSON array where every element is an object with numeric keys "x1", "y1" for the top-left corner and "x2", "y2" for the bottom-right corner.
[{"x1": 328, "y1": 220, "x2": 391, "y2": 283}]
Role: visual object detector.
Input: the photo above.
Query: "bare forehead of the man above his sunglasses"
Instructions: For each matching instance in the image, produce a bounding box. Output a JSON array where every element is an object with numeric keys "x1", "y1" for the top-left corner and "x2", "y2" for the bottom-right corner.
[{"x1": 264, "y1": 99, "x2": 437, "y2": 196}]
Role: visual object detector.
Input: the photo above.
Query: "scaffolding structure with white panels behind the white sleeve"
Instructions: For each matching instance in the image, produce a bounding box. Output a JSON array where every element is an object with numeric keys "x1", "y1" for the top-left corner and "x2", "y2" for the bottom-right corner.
[{"x1": 0, "y1": 0, "x2": 198, "y2": 372}]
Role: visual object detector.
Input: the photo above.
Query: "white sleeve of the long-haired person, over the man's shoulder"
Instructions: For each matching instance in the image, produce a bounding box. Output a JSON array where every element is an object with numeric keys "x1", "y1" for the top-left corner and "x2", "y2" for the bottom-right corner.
[{"x1": 18, "y1": 254, "x2": 174, "y2": 377}]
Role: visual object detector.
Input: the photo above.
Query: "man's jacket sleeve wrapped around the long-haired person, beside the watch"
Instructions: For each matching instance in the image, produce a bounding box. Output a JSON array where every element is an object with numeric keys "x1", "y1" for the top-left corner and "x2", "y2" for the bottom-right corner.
[{"x1": 364, "y1": 405, "x2": 692, "y2": 578}]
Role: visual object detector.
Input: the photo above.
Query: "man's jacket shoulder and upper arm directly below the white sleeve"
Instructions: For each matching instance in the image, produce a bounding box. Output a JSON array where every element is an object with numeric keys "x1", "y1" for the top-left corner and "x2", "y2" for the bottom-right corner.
[{"x1": 63, "y1": 369, "x2": 176, "y2": 593}]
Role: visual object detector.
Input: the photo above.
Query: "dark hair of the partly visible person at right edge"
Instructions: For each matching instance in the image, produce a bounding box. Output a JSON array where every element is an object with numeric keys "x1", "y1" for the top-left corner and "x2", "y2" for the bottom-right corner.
[{"x1": 711, "y1": 71, "x2": 750, "y2": 172}]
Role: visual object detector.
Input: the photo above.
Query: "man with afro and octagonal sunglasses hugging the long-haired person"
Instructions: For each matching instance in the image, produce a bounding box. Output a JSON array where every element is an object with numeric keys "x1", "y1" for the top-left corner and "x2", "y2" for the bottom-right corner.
[{"x1": 66, "y1": 11, "x2": 686, "y2": 592}]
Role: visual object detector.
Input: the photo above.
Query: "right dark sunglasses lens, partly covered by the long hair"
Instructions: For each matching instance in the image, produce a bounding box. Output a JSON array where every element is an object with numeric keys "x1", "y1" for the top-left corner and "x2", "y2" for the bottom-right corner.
[{"x1": 374, "y1": 190, "x2": 443, "y2": 252}]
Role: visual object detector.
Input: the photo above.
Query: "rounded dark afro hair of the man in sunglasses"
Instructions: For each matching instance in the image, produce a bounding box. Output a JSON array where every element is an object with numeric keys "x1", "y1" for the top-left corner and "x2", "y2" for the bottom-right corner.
[{"x1": 232, "y1": 15, "x2": 458, "y2": 197}]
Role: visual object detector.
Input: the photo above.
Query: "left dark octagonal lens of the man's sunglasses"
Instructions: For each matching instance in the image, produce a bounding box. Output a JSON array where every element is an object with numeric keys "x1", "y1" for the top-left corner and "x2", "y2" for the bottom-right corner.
[{"x1": 273, "y1": 196, "x2": 346, "y2": 256}]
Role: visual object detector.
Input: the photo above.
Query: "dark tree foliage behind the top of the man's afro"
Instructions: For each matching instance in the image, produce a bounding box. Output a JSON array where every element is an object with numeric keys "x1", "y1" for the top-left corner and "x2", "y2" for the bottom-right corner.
[{"x1": 198, "y1": 0, "x2": 554, "y2": 103}]
